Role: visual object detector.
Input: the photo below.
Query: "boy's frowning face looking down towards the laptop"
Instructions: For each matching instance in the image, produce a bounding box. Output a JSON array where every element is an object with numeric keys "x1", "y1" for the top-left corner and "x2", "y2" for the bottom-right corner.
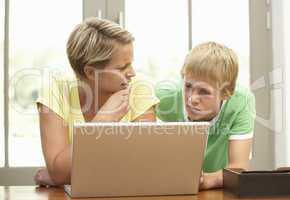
[{"x1": 183, "y1": 75, "x2": 223, "y2": 121}]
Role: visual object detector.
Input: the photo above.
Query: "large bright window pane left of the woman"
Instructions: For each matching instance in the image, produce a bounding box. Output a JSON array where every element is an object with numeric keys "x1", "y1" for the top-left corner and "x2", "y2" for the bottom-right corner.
[{"x1": 7, "y1": 0, "x2": 82, "y2": 167}]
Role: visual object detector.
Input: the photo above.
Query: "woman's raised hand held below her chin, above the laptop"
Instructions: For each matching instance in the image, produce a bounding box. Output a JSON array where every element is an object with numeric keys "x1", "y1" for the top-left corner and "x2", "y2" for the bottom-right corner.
[{"x1": 95, "y1": 88, "x2": 130, "y2": 122}]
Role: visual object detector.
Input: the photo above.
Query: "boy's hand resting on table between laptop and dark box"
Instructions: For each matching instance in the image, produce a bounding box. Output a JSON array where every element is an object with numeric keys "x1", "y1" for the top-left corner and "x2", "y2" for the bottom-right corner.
[{"x1": 199, "y1": 171, "x2": 223, "y2": 190}]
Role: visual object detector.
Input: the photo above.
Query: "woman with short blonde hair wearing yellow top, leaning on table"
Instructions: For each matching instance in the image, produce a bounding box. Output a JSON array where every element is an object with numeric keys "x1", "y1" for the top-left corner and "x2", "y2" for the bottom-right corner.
[{"x1": 34, "y1": 18, "x2": 158, "y2": 185}]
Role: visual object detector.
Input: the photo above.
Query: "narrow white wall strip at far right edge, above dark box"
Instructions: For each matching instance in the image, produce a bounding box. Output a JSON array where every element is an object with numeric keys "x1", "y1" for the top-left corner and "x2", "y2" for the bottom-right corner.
[{"x1": 272, "y1": 0, "x2": 290, "y2": 168}]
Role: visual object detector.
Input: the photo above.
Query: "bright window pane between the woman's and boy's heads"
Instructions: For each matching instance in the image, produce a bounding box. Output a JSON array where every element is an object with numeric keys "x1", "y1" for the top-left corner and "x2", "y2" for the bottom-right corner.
[{"x1": 125, "y1": 0, "x2": 188, "y2": 80}]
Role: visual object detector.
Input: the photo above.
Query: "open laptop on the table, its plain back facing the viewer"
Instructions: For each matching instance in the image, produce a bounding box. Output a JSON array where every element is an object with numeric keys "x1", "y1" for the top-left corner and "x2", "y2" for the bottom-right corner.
[{"x1": 64, "y1": 122, "x2": 210, "y2": 198}]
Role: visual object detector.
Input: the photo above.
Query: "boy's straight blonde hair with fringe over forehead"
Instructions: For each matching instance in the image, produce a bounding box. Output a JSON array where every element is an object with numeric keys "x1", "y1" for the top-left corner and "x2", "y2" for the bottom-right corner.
[{"x1": 182, "y1": 42, "x2": 239, "y2": 96}]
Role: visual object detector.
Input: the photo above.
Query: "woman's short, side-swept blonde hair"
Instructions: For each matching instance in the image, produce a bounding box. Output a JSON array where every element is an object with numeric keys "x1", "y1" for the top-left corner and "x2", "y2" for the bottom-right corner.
[{"x1": 67, "y1": 18, "x2": 134, "y2": 76}]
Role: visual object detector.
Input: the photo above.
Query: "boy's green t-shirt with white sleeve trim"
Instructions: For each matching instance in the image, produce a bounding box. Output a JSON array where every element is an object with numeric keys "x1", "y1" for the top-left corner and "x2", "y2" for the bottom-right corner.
[{"x1": 155, "y1": 80, "x2": 256, "y2": 172}]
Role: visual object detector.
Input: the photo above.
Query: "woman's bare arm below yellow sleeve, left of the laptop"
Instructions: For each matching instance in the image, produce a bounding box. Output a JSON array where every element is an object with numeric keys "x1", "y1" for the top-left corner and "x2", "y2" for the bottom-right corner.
[{"x1": 38, "y1": 104, "x2": 71, "y2": 185}]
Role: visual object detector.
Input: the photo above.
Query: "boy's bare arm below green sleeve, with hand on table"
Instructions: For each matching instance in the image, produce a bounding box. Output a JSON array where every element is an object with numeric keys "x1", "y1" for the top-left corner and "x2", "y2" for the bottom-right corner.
[{"x1": 199, "y1": 139, "x2": 252, "y2": 190}]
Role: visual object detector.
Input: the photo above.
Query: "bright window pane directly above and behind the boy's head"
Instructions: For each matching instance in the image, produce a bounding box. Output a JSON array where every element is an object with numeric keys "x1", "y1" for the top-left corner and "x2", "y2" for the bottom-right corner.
[{"x1": 192, "y1": 0, "x2": 250, "y2": 86}]
